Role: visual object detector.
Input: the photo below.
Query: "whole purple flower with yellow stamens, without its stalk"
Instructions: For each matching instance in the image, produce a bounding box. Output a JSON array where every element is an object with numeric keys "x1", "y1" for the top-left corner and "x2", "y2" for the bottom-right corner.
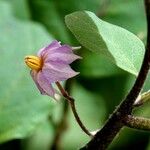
[{"x1": 25, "y1": 40, "x2": 81, "y2": 98}]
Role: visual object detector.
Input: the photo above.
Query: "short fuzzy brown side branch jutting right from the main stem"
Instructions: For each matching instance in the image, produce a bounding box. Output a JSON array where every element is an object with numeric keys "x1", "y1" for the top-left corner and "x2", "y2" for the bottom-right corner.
[{"x1": 125, "y1": 115, "x2": 150, "y2": 131}]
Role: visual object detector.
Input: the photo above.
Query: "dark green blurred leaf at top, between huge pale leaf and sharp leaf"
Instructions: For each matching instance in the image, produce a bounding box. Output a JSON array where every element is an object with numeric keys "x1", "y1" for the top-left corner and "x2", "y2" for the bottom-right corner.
[{"x1": 29, "y1": 0, "x2": 69, "y2": 42}]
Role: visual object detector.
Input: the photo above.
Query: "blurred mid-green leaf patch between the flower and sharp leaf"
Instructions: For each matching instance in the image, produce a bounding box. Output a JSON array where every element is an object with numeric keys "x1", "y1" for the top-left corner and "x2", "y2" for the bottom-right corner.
[{"x1": 77, "y1": 49, "x2": 125, "y2": 78}]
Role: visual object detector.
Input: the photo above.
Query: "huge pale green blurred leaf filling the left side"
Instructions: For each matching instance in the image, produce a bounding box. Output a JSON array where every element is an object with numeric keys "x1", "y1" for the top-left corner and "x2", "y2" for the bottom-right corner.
[{"x1": 0, "y1": 2, "x2": 52, "y2": 142}]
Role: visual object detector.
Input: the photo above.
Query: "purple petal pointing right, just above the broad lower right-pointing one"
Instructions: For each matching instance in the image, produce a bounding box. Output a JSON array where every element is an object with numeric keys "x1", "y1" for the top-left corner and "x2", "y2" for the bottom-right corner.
[{"x1": 44, "y1": 52, "x2": 81, "y2": 64}]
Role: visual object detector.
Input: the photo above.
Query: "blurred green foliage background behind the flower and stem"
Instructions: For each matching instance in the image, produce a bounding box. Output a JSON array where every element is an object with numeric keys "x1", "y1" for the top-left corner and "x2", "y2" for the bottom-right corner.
[{"x1": 0, "y1": 0, "x2": 150, "y2": 150}]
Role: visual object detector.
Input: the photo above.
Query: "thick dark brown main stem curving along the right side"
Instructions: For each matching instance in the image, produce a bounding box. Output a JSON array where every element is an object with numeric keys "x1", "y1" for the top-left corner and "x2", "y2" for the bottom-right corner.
[{"x1": 81, "y1": 0, "x2": 150, "y2": 150}]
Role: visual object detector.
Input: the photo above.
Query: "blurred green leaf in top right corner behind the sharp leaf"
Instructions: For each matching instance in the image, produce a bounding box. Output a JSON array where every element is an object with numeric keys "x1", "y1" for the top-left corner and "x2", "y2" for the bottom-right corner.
[{"x1": 102, "y1": 0, "x2": 146, "y2": 39}]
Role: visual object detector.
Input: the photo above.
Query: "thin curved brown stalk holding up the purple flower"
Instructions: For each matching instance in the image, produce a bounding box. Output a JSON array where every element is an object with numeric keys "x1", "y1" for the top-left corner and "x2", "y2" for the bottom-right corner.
[{"x1": 56, "y1": 82, "x2": 93, "y2": 137}]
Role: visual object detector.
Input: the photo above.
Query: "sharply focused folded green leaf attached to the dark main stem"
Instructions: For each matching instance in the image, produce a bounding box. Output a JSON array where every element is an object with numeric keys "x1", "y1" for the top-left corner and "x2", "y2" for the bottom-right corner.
[{"x1": 65, "y1": 11, "x2": 145, "y2": 75}]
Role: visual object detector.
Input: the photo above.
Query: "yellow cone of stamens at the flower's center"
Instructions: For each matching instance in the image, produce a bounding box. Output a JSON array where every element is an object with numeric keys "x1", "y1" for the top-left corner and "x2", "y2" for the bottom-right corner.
[{"x1": 25, "y1": 55, "x2": 43, "y2": 71}]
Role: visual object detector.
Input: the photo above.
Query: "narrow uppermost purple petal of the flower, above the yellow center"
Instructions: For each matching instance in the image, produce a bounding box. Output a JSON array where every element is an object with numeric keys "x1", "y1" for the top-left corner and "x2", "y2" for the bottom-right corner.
[{"x1": 37, "y1": 40, "x2": 61, "y2": 57}]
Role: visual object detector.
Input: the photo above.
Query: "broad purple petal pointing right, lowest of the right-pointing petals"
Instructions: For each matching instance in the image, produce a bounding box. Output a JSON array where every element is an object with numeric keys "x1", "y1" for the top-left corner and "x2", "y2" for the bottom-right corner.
[{"x1": 42, "y1": 62, "x2": 79, "y2": 83}]
